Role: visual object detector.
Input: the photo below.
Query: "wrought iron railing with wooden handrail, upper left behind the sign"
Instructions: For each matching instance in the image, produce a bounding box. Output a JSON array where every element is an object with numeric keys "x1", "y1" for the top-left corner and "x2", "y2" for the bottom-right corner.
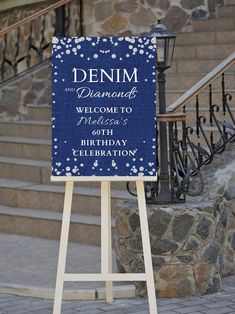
[{"x1": 0, "y1": 0, "x2": 83, "y2": 84}]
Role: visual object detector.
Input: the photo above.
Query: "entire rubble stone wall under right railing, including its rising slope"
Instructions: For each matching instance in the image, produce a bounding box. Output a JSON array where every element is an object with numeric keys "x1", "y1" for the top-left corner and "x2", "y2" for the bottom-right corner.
[{"x1": 115, "y1": 143, "x2": 235, "y2": 298}]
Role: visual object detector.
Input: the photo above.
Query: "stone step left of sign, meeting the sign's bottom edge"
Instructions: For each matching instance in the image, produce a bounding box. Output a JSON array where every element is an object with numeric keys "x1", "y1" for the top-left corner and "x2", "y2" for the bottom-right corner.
[{"x1": 0, "y1": 156, "x2": 126, "y2": 190}]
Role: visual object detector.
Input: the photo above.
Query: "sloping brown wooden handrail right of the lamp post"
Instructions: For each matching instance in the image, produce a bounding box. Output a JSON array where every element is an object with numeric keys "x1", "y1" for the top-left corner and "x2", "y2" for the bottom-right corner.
[{"x1": 167, "y1": 52, "x2": 235, "y2": 112}]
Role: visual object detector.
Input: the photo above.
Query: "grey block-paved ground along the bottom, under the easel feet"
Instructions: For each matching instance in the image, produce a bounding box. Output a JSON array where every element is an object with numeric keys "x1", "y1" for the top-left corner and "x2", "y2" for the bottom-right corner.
[{"x1": 0, "y1": 276, "x2": 235, "y2": 314}]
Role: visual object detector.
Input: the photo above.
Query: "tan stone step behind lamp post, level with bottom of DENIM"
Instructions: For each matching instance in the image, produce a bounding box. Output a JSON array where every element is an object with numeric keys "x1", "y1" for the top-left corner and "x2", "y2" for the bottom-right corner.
[{"x1": 166, "y1": 72, "x2": 235, "y2": 90}]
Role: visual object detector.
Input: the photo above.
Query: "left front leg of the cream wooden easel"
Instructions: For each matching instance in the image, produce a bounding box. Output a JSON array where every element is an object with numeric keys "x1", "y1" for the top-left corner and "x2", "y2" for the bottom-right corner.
[{"x1": 53, "y1": 182, "x2": 73, "y2": 314}]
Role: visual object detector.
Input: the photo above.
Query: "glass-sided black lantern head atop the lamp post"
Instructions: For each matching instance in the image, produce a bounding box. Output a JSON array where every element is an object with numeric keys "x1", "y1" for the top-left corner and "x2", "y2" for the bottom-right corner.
[{"x1": 148, "y1": 20, "x2": 176, "y2": 72}]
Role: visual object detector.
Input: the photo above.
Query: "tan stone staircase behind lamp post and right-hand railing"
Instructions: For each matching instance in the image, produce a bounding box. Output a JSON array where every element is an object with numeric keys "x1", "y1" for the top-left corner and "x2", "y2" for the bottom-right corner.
[{"x1": 166, "y1": 6, "x2": 235, "y2": 142}]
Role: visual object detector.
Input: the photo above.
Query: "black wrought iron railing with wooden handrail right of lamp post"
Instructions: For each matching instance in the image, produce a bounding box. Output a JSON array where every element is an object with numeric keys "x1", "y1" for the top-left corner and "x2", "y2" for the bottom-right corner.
[{"x1": 167, "y1": 52, "x2": 235, "y2": 201}]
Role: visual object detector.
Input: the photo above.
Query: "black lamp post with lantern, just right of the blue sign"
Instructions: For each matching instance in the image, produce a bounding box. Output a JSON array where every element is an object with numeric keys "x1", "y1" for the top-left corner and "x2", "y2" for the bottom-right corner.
[{"x1": 148, "y1": 21, "x2": 176, "y2": 204}]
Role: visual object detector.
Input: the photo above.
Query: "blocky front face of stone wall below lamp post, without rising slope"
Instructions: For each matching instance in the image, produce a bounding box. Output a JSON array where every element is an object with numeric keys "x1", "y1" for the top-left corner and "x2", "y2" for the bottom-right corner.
[{"x1": 116, "y1": 201, "x2": 222, "y2": 298}]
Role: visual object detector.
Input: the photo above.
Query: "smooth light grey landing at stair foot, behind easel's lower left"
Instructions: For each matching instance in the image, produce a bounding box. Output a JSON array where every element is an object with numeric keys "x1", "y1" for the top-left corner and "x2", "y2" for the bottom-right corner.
[{"x1": 0, "y1": 234, "x2": 125, "y2": 292}]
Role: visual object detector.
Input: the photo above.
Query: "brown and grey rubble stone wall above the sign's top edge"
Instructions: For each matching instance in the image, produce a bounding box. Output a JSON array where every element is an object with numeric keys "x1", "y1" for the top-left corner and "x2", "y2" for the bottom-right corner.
[{"x1": 84, "y1": 0, "x2": 209, "y2": 36}]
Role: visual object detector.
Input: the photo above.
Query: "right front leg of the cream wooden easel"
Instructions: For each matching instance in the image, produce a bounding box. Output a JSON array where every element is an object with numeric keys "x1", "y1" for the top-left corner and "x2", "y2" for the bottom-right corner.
[{"x1": 136, "y1": 181, "x2": 157, "y2": 314}]
